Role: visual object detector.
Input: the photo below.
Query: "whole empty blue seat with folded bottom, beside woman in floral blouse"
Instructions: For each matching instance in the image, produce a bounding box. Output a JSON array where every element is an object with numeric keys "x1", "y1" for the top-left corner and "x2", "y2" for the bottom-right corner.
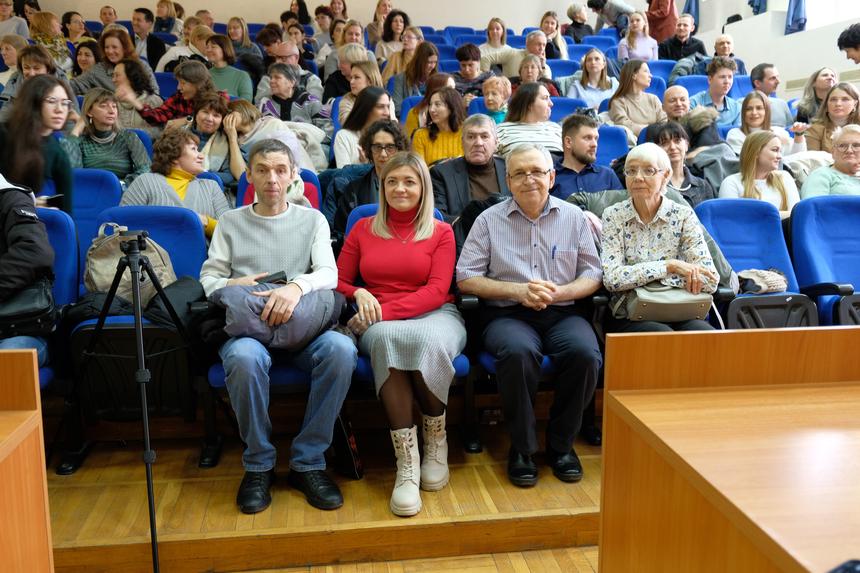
[{"x1": 696, "y1": 199, "x2": 818, "y2": 328}]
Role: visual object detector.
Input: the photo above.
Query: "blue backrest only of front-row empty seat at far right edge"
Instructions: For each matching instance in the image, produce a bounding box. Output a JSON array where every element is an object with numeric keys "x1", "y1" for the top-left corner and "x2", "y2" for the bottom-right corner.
[{"x1": 791, "y1": 196, "x2": 860, "y2": 292}]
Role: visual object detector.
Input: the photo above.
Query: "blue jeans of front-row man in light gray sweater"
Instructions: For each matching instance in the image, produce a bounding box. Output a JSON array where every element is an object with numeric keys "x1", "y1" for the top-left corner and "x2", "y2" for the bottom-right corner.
[{"x1": 219, "y1": 330, "x2": 358, "y2": 472}]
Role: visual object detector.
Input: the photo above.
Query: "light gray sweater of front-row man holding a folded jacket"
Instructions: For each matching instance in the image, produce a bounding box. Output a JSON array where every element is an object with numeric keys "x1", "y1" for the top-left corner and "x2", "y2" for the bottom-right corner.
[{"x1": 200, "y1": 204, "x2": 337, "y2": 296}]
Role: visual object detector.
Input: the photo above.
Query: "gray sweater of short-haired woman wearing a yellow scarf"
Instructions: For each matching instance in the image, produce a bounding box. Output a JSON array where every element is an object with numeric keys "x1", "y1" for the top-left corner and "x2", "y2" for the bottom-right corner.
[{"x1": 119, "y1": 173, "x2": 230, "y2": 220}]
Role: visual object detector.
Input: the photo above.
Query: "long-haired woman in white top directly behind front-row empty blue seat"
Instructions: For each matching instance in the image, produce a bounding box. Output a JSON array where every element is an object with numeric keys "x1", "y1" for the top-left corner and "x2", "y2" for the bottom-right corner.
[{"x1": 720, "y1": 131, "x2": 800, "y2": 218}]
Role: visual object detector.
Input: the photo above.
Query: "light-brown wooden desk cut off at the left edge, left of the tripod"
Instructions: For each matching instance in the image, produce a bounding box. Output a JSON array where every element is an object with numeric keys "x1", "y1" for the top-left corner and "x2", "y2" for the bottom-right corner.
[{"x1": 0, "y1": 350, "x2": 54, "y2": 573}]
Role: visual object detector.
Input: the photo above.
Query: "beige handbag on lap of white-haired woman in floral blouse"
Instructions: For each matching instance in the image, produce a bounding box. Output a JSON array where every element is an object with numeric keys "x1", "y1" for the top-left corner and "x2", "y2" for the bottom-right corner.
[{"x1": 612, "y1": 281, "x2": 713, "y2": 322}]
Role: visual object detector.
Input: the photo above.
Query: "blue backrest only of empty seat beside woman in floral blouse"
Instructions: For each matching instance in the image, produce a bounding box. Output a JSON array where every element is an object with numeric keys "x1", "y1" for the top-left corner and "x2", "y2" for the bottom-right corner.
[{"x1": 696, "y1": 199, "x2": 799, "y2": 292}]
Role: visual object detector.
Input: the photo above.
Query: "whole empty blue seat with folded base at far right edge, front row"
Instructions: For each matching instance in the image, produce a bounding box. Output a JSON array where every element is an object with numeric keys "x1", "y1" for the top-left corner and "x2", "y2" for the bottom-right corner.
[{"x1": 791, "y1": 196, "x2": 860, "y2": 325}]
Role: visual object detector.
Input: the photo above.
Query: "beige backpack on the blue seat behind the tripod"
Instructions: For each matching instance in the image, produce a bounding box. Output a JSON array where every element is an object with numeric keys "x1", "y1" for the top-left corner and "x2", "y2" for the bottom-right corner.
[{"x1": 84, "y1": 223, "x2": 176, "y2": 307}]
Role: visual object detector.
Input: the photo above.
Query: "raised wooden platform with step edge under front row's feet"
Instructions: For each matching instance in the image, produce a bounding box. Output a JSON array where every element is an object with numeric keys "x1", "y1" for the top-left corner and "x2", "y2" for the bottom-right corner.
[{"x1": 48, "y1": 428, "x2": 600, "y2": 573}]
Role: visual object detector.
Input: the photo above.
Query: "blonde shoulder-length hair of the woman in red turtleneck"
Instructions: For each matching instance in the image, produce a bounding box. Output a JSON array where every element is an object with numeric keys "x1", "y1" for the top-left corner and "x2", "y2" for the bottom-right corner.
[{"x1": 370, "y1": 151, "x2": 436, "y2": 243}]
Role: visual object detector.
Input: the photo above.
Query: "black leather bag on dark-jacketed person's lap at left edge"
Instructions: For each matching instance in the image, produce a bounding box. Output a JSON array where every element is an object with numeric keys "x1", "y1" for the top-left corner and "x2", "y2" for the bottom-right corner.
[{"x1": 0, "y1": 278, "x2": 57, "y2": 338}]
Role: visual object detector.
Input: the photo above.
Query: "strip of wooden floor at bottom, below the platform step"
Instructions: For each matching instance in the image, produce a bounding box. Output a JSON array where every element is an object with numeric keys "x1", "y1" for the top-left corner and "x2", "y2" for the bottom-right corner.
[{"x1": 245, "y1": 547, "x2": 597, "y2": 573}]
